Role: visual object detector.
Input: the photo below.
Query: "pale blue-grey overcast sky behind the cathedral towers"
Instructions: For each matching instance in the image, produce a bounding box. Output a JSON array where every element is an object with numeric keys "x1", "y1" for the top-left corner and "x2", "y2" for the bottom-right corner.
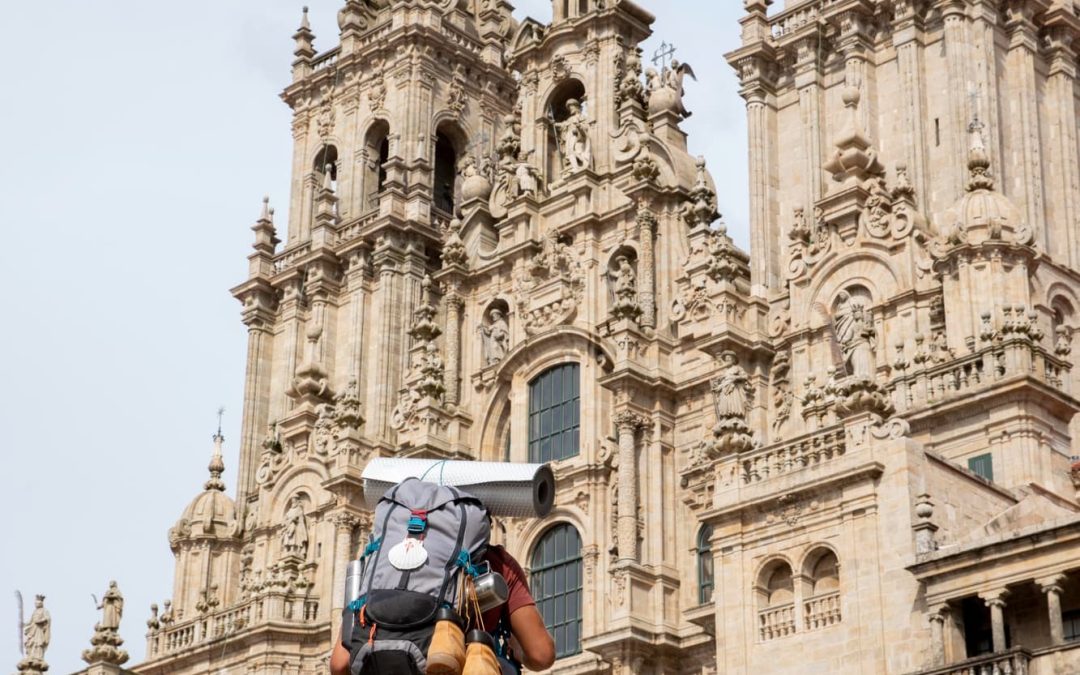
[{"x1": 0, "y1": 0, "x2": 747, "y2": 674}]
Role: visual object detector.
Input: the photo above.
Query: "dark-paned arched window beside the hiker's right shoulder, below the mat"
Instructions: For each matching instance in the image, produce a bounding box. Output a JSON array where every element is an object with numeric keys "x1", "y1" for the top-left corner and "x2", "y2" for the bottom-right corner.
[{"x1": 530, "y1": 523, "x2": 582, "y2": 659}]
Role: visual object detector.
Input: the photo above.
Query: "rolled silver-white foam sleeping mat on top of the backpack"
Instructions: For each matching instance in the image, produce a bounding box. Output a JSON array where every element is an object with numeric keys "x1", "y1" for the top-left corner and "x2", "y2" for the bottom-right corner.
[{"x1": 362, "y1": 457, "x2": 555, "y2": 518}]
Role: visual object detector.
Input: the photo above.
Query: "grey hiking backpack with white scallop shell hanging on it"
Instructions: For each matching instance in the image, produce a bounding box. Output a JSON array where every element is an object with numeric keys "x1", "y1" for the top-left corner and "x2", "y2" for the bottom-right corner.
[{"x1": 341, "y1": 478, "x2": 491, "y2": 675}]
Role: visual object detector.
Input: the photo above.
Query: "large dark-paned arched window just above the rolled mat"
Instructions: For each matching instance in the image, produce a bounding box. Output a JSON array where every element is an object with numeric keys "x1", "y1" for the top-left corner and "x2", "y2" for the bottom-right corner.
[{"x1": 529, "y1": 363, "x2": 581, "y2": 463}]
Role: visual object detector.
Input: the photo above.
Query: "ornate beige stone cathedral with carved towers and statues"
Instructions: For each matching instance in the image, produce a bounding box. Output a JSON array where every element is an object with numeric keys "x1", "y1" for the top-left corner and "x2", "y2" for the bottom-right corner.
[{"x1": 67, "y1": 0, "x2": 1080, "y2": 675}]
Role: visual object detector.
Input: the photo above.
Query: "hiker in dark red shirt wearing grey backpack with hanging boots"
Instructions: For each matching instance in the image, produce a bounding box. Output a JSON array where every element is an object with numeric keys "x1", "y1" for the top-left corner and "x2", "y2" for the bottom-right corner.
[{"x1": 330, "y1": 478, "x2": 555, "y2": 675}]
